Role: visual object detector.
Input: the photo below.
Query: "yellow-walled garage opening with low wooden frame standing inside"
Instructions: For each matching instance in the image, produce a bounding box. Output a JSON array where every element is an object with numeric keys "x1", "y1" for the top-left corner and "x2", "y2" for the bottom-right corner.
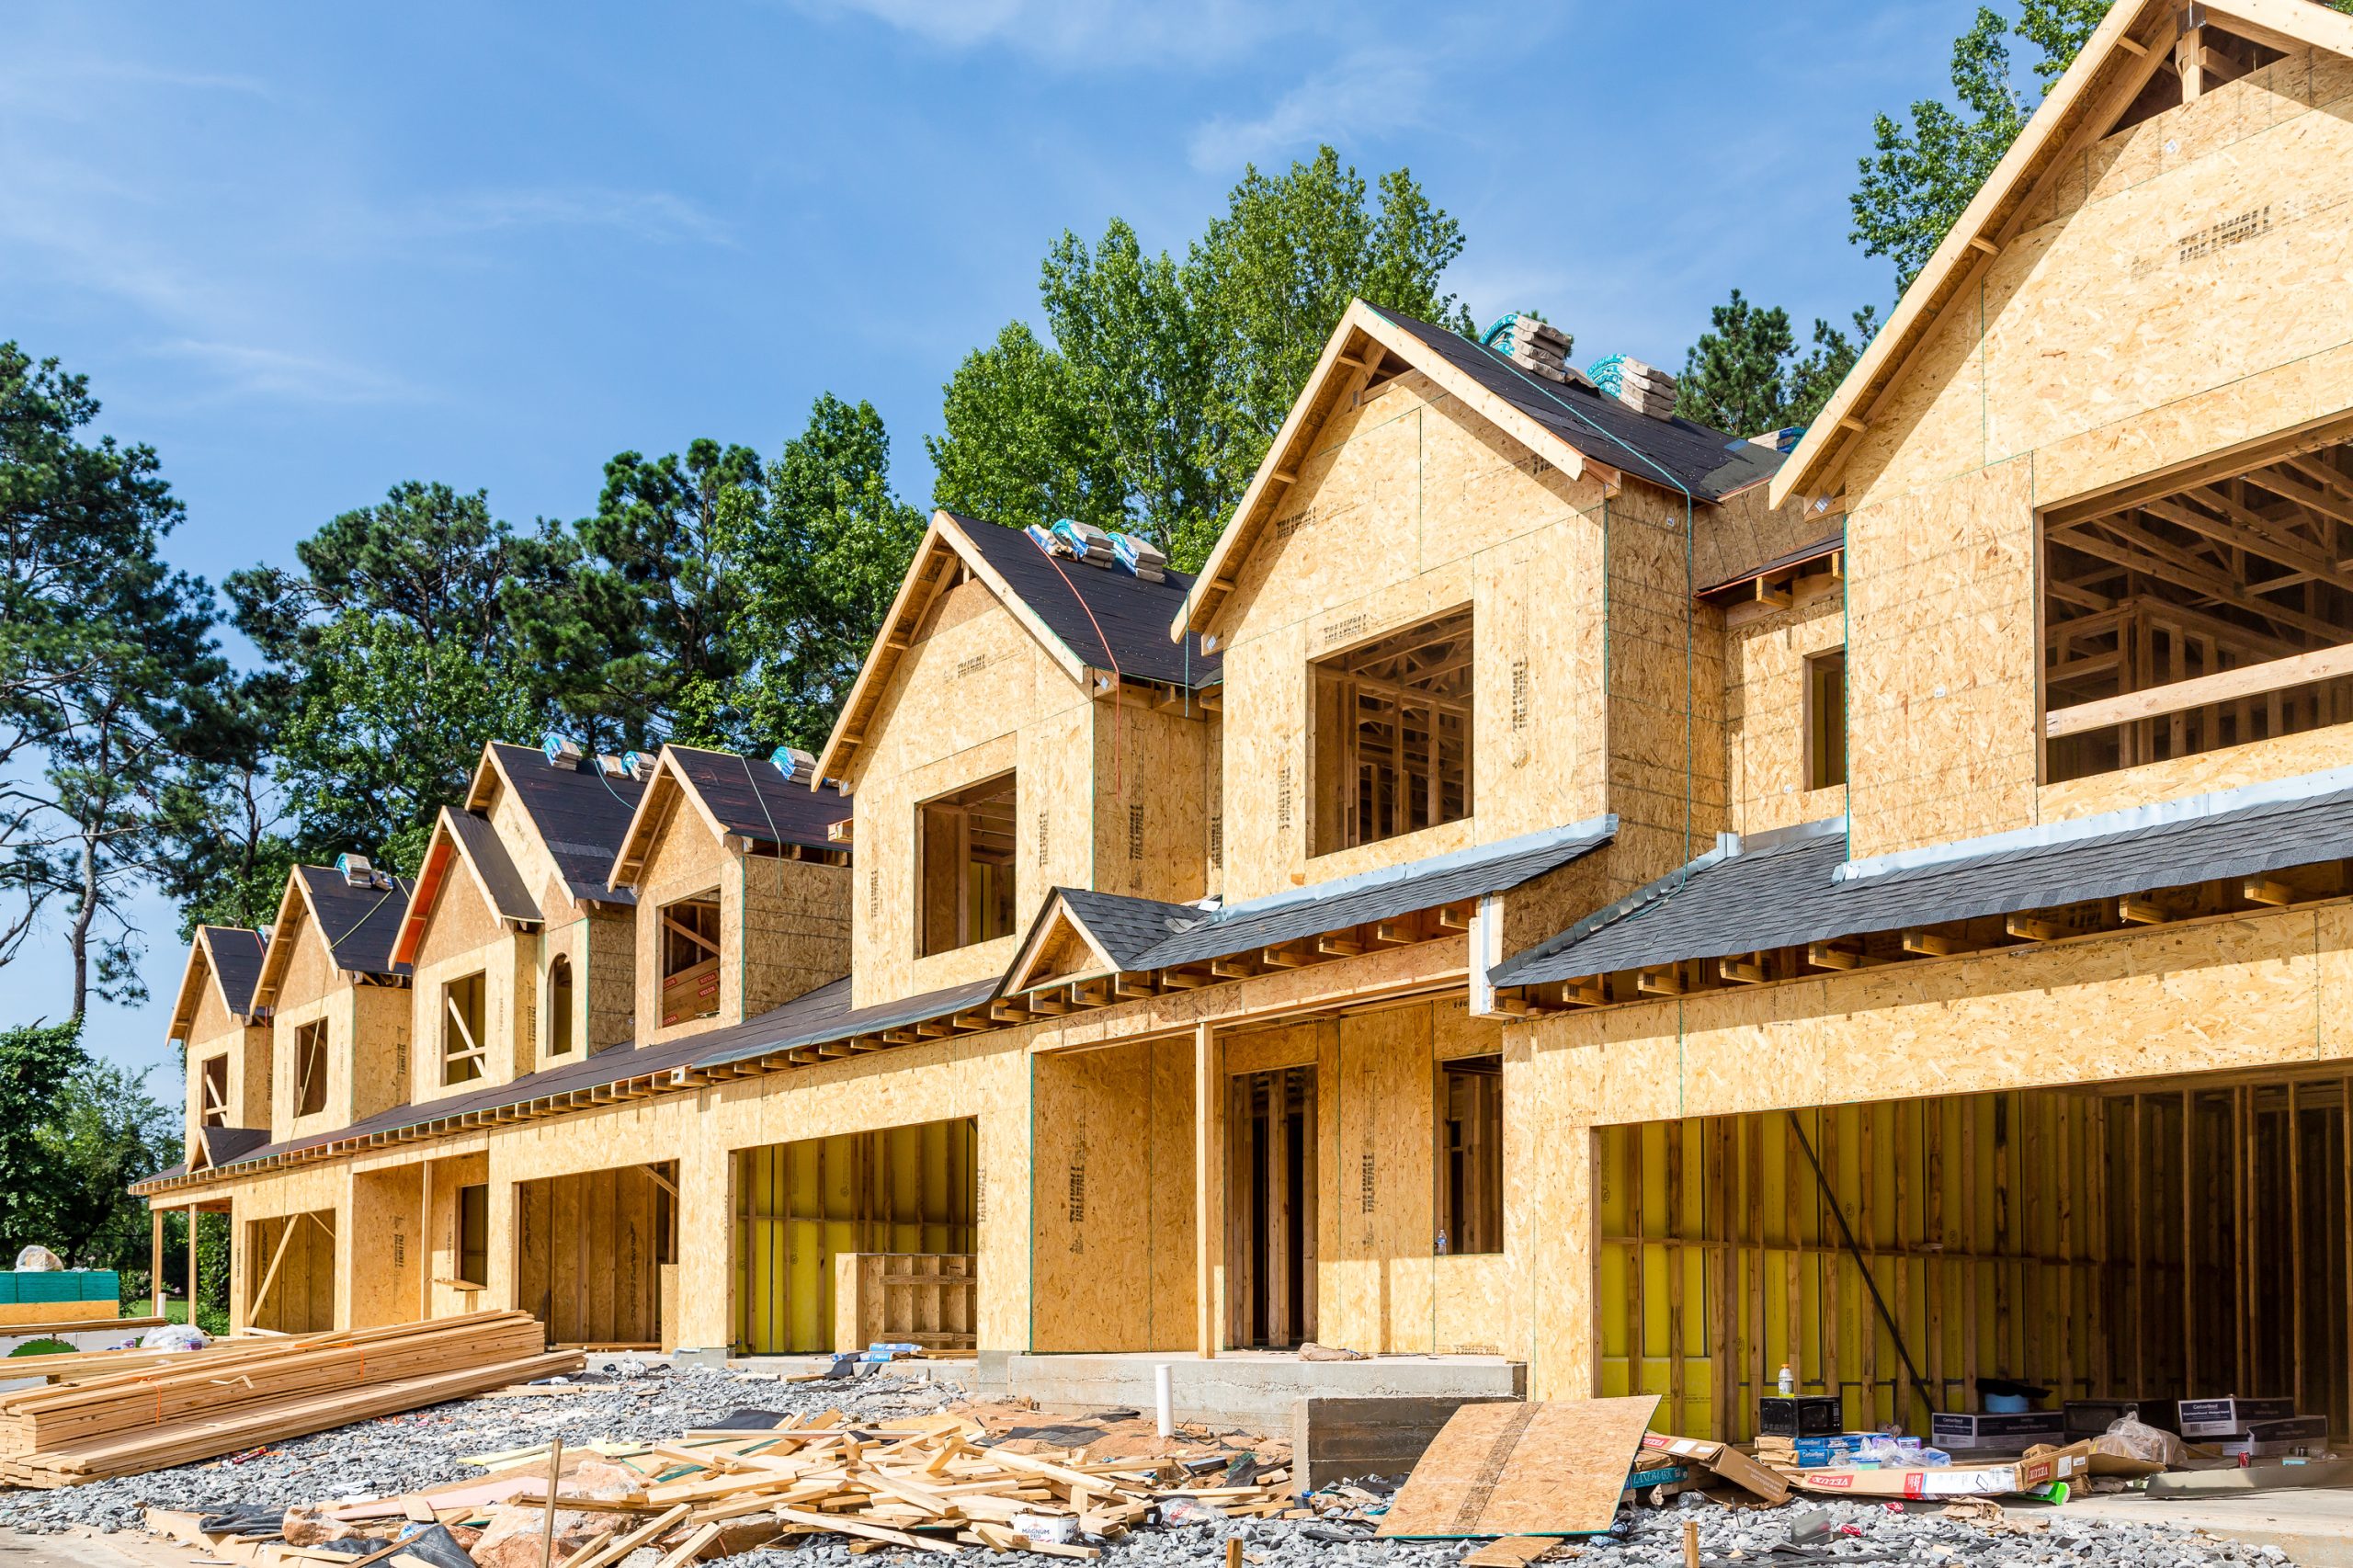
[{"x1": 734, "y1": 1116, "x2": 979, "y2": 1356}]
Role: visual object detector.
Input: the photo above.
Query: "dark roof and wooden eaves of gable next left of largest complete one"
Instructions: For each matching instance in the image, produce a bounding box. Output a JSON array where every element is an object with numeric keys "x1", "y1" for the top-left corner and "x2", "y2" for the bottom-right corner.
[{"x1": 816, "y1": 508, "x2": 1222, "y2": 779}]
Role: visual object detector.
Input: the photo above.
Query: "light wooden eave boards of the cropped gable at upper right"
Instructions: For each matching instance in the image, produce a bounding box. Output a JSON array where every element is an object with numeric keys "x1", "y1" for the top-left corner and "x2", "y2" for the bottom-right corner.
[{"x1": 1772, "y1": 0, "x2": 2353, "y2": 506}]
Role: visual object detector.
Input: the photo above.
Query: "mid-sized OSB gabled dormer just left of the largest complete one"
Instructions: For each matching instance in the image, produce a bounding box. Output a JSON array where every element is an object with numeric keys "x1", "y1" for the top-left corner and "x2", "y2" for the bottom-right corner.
[{"x1": 816, "y1": 511, "x2": 1222, "y2": 1007}]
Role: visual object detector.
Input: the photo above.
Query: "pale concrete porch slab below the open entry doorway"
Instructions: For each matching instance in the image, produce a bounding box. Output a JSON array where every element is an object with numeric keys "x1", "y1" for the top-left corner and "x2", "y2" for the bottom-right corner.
[{"x1": 979, "y1": 1351, "x2": 1527, "y2": 1434}]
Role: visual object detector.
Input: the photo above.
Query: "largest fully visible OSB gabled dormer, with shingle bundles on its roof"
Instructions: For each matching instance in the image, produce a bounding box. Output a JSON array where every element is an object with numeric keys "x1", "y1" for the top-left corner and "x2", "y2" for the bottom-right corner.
[{"x1": 1169, "y1": 301, "x2": 1824, "y2": 923}]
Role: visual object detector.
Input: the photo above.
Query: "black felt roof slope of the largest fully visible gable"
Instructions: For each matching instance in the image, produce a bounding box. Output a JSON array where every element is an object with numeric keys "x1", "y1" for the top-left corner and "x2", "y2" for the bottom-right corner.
[{"x1": 1381, "y1": 311, "x2": 1786, "y2": 502}]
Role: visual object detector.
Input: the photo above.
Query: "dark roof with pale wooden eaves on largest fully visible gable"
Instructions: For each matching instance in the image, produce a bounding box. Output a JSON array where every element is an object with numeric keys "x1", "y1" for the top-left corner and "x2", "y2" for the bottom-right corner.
[{"x1": 1169, "y1": 299, "x2": 1783, "y2": 638}]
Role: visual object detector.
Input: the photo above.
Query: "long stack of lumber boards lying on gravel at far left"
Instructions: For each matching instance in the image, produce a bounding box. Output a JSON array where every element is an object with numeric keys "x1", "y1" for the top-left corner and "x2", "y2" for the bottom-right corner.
[{"x1": 0, "y1": 1312, "x2": 581, "y2": 1488}]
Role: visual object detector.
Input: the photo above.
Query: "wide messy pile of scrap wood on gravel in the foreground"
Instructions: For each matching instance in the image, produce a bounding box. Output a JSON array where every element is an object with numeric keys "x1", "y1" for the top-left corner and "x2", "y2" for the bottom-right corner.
[{"x1": 148, "y1": 1410, "x2": 1313, "y2": 1568}]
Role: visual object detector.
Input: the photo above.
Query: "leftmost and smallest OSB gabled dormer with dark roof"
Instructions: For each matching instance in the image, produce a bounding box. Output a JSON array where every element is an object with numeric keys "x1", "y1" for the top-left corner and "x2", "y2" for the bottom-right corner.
[{"x1": 172, "y1": 926, "x2": 270, "y2": 1170}]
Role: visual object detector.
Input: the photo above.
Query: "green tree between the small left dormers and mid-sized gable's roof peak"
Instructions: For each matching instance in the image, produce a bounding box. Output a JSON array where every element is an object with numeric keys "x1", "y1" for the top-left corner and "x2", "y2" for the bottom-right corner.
[{"x1": 718, "y1": 393, "x2": 925, "y2": 751}]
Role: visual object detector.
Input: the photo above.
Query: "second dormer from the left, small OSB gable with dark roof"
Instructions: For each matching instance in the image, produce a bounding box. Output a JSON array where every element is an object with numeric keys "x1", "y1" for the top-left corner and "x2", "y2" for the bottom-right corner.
[{"x1": 254, "y1": 855, "x2": 412, "y2": 1140}]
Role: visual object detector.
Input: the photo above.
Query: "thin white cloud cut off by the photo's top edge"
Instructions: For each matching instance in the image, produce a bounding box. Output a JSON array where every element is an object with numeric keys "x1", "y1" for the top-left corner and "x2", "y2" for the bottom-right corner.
[{"x1": 798, "y1": 0, "x2": 1299, "y2": 66}]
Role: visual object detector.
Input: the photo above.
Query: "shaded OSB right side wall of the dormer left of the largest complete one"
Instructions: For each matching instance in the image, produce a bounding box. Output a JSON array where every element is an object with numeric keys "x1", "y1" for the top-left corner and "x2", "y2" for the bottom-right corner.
[{"x1": 1086, "y1": 692, "x2": 1207, "y2": 904}]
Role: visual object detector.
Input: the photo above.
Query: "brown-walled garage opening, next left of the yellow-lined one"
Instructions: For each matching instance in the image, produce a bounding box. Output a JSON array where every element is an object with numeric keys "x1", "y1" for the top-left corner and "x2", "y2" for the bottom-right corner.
[{"x1": 517, "y1": 1161, "x2": 677, "y2": 1349}]
